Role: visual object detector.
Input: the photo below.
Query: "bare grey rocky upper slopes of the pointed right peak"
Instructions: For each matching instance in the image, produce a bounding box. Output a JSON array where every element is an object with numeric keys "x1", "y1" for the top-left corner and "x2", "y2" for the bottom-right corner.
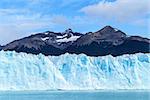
[{"x1": 74, "y1": 26, "x2": 126, "y2": 45}]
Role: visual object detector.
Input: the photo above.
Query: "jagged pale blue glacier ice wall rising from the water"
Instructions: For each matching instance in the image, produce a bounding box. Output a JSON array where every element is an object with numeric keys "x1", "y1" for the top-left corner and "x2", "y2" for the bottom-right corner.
[{"x1": 0, "y1": 51, "x2": 150, "y2": 90}]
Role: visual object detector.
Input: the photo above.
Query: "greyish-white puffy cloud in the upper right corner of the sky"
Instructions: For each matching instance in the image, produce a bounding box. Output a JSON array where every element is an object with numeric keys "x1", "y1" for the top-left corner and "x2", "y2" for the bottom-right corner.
[{"x1": 80, "y1": 0, "x2": 150, "y2": 22}]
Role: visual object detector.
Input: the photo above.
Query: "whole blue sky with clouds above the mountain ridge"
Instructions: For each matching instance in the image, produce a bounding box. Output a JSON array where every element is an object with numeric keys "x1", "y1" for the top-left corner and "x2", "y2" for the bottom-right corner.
[{"x1": 0, "y1": 0, "x2": 150, "y2": 45}]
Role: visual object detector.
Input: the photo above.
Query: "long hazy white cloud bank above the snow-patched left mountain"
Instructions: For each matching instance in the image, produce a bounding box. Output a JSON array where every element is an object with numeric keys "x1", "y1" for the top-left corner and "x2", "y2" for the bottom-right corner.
[{"x1": 0, "y1": 9, "x2": 98, "y2": 45}]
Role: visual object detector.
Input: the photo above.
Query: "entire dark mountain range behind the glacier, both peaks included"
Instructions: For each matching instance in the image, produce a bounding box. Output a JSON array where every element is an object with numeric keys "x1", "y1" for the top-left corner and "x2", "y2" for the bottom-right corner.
[{"x1": 3, "y1": 26, "x2": 150, "y2": 56}]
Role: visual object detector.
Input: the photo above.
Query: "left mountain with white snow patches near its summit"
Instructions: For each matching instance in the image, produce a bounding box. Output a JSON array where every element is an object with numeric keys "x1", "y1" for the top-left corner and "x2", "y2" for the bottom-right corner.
[{"x1": 3, "y1": 29, "x2": 82, "y2": 55}]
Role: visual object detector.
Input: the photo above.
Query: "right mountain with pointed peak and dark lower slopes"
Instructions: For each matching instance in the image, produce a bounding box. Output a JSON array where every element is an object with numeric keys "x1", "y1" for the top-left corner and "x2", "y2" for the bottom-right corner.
[{"x1": 67, "y1": 26, "x2": 150, "y2": 56}]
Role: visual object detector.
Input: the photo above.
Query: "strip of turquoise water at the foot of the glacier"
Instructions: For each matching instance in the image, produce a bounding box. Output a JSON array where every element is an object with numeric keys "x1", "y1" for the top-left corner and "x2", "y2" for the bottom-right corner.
[{"x1": 0, "y1": 91, "x2": 150, "y2": 100}]
